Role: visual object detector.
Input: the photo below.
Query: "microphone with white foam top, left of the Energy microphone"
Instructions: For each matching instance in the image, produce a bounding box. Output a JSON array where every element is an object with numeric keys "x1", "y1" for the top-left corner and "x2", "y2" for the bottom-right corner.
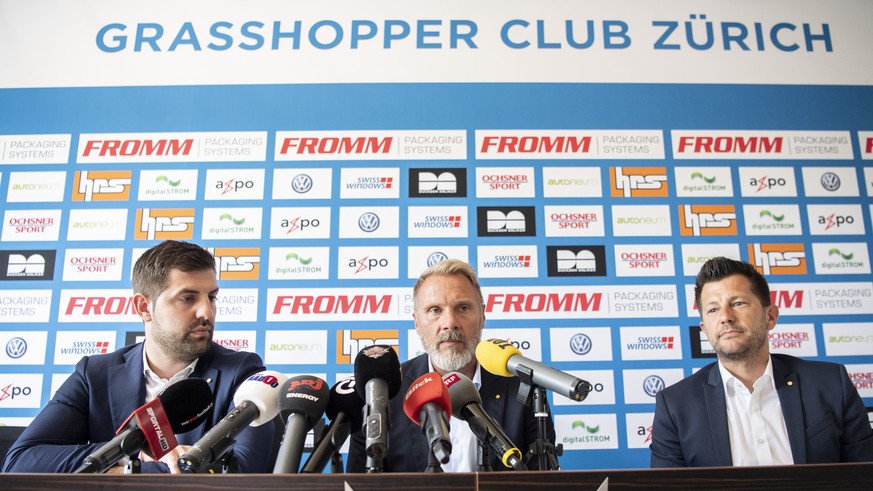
[{"x1": 178, "y1": 370, "x2": 288, "y2": 473}]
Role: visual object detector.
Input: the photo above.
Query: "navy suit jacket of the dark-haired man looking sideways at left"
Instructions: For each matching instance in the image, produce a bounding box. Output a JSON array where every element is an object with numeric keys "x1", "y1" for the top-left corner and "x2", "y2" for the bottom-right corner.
[{"x1": 3, "y1": 343, "x2": 273, "y2": 472}]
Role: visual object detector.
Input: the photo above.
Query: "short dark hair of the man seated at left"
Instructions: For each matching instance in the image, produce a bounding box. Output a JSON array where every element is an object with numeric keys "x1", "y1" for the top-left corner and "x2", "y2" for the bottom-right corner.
[{"x1": 130, "y1": 240, "x2": 215, "y2": 301}]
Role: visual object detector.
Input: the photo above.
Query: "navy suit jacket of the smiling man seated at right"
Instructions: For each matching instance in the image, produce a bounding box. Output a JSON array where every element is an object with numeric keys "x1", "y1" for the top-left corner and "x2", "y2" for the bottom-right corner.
[{"x1": 650, "y1": 354, "x2": 873, "y2": 467}]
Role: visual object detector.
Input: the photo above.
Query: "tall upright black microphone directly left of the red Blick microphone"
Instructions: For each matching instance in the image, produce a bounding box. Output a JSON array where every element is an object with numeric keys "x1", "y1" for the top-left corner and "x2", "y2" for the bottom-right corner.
[{"x1": 355, "y1": 344, "x2": 400, "y2": 472}]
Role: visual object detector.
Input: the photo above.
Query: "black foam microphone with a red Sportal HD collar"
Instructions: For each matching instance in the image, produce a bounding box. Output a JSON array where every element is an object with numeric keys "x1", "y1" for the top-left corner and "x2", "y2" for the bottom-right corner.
[{"x1": 75, "y1": 378, "x2": 213, "y2": 474}]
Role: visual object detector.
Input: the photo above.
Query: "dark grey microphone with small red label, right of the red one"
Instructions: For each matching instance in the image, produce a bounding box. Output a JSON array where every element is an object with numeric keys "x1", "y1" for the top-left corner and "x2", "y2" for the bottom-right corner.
[{"x1": 443, "y1": 372, "x2": 527, "y2": 471}]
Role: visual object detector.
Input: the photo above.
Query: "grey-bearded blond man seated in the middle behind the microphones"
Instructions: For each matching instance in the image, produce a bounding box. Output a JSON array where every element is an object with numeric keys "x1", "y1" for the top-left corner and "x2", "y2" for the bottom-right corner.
[{"x1": 346, "y1": 259, "x2": 555, "y2": 472}]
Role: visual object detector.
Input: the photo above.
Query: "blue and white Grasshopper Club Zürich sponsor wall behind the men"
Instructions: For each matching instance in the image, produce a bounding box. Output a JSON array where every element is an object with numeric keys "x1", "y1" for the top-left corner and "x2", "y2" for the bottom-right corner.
[{"x1": 0, "y1": 0, "x2": 873, "y2": 469}]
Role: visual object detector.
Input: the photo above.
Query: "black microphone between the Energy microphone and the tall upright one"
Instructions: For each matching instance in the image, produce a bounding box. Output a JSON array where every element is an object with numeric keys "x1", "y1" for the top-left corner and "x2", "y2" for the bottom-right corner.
[{"x1": 300, "y1": 377, "x2": 364, "y2": 474}]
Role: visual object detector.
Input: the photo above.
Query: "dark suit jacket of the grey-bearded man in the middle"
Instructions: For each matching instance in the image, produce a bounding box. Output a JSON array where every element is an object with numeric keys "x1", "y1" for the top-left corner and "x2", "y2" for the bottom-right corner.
[{"x1": 346, "y1": 355, "x2": 555, "y2": 472}]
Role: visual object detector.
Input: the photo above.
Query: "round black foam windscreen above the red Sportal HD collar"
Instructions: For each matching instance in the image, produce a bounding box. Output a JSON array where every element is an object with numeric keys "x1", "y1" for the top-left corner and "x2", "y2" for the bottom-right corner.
[{"x1": 157, "y1": 378, "x2": 215, "y2": 434}]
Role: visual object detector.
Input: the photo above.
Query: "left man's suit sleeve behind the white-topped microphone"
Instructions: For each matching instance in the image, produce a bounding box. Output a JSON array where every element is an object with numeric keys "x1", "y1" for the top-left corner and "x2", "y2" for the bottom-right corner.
[{"x1": 216, "y1": 353, "x2": 275, "y2": 473}]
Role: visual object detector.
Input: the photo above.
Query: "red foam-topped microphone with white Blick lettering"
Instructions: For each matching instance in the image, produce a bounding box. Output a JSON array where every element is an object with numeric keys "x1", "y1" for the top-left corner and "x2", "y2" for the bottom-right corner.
[{"x1": 403, "y1": 372, "x2": 452, "y2": 464}]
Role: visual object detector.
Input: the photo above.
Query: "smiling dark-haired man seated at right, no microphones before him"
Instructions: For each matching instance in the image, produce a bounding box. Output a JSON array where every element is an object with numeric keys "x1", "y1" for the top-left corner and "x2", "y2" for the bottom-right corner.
[{"x1": 650, "y1": 257, "x2": 873, "y2": 467}]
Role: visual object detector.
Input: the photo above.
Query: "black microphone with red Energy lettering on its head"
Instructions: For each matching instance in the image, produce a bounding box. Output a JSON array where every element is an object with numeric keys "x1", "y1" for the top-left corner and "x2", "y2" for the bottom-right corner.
[{"x1": 273, "y1": 375, "x2": 330, "y2": 474}]
